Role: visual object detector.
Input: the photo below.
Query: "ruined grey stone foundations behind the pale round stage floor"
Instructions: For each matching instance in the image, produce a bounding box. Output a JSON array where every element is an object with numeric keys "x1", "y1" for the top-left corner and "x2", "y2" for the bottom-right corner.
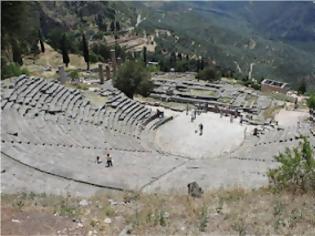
[{"x1": 151, "y1": 73, "x2": 273, "y2": 124}]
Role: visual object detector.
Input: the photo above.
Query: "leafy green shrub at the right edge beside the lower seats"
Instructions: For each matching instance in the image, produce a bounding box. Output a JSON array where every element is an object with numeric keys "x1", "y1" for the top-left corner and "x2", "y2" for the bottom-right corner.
[{"x1": 268, "y1": 138, "x2": 315, "y2": 192}]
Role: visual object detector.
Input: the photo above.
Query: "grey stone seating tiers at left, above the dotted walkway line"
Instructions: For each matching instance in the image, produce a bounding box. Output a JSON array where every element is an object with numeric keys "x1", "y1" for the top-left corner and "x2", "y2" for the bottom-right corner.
[{"x1": 1, "y1": 76, "x2": 169, "y2": 155}]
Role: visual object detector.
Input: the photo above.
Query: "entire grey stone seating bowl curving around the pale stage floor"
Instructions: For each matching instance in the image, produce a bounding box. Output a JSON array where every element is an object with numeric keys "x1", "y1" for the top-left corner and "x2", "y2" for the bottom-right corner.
[{"x1": 1, "y1": 76, "x2": 315, "y2": 195}]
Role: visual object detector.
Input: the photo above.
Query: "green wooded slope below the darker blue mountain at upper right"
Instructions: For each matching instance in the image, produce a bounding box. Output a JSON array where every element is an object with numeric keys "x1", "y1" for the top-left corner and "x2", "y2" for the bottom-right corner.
[{"x1": 137, "y1": 3, "x2": 315, "y2": 89}]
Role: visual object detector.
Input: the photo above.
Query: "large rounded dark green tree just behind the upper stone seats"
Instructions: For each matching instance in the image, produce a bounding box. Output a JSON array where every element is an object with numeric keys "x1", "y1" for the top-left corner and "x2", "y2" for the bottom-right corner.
[{"x1": 113, "y1": 61, "x2": 153, "y2": 98}]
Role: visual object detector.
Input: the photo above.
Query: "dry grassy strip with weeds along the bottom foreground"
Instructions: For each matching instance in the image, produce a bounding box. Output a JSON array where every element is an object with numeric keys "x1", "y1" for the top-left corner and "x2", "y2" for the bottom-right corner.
[{"x1": 1, "y1": 189, "x2": 315, "y2": 235}]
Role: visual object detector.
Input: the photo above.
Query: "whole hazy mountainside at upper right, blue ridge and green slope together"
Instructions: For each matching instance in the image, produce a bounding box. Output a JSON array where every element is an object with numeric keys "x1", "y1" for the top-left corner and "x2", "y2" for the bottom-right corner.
[{"x1": 135, "y1": 2, "x2": 315, "y2": 86}]
